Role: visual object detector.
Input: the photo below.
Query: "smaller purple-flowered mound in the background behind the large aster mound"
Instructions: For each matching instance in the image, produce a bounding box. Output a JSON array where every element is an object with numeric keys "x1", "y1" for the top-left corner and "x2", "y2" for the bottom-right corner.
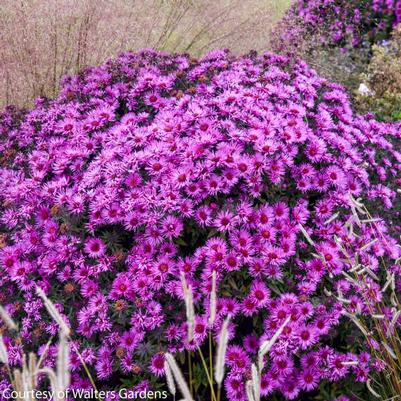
[{"x1": 275, "y1": 0, "x2": 401, "y2": 49}]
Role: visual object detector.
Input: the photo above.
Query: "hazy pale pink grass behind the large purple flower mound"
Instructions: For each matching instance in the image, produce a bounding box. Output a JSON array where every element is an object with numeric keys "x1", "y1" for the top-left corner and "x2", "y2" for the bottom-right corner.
[{"x1": 0, "y1": 0, "x2": 291, "y2": 108}]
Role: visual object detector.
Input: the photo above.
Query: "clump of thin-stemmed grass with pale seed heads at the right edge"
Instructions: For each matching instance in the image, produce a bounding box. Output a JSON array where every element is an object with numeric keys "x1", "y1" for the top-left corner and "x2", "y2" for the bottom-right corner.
[{"x1": 310, "y1": 196, "x2": 401, "y2": 400}]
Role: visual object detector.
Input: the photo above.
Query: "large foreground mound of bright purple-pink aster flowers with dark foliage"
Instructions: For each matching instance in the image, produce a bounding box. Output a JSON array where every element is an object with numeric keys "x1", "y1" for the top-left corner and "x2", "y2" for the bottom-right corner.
[{"x1": 0, "y1": 50, "x2": 401, "y2": 400}]
